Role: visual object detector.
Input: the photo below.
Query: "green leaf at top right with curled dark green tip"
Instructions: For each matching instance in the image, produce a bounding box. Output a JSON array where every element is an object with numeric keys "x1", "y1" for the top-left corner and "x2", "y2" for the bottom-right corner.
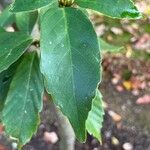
[{"x1": 75, "y1": 0, "x2": 142, "y2": 19}]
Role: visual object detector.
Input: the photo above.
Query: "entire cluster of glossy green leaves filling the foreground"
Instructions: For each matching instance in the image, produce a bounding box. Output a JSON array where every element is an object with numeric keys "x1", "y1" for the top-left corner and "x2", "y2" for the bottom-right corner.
[{"x1": 0, "y1": 0, "x2": 141, "y2": 147}]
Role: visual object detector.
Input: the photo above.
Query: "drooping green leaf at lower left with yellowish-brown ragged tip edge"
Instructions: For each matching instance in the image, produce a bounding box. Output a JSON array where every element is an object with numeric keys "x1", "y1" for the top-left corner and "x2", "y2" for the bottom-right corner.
[{"x1": 2, "y1": 53, "x2": 44, "y2": 145}]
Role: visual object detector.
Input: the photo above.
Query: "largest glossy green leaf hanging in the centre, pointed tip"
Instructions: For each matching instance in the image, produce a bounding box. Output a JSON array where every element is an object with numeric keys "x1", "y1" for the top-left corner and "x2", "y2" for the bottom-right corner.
[{"x1": 41, "y1": 8, "x2": 100, "y2": 141}]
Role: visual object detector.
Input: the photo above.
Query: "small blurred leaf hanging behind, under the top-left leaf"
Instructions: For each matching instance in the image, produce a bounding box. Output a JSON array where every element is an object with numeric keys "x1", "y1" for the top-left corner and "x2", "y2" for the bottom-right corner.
[{"x1": 16, "y1": 11, "x2": 38, "y2": 34}]
